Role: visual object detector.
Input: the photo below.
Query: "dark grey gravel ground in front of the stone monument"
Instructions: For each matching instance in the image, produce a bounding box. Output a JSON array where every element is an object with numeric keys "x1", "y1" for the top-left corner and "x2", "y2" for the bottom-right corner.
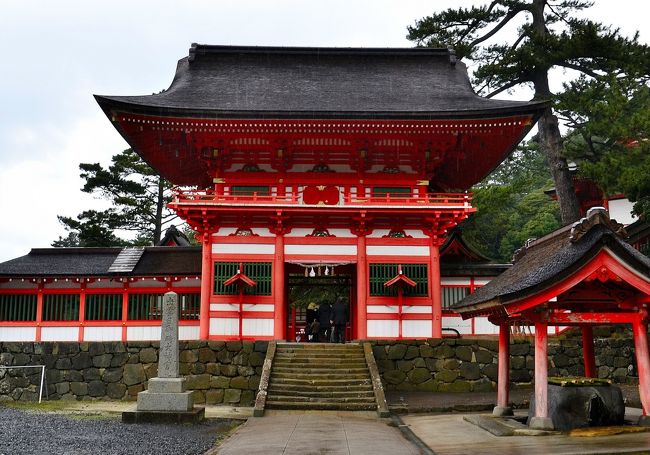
[{"x1": 0, "y1": 406, "x2": 238, "y2": 455}]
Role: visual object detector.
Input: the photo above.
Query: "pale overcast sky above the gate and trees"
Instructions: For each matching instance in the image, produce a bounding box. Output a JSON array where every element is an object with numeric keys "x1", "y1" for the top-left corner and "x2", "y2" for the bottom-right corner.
[{"x1": 0, "y1": 0, "x2": 650, "y2": 261}]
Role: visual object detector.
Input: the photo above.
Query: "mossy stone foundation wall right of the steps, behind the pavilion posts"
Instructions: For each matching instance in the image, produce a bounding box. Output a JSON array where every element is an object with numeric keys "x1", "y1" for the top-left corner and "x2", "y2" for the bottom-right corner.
[{"x1": 371, "y1": 338, "x2": 638, "y2": 392}]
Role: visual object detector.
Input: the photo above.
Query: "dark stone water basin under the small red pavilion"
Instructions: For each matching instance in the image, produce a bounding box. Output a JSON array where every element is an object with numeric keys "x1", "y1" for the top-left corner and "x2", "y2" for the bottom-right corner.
[{"x1": 528, "y1": 378, "x2": 625, "y2": 431}]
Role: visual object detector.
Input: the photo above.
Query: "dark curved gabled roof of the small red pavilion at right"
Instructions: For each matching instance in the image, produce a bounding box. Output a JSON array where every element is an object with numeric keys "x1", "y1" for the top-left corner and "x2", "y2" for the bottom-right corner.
[{"x1": 453, "y1": 211, "x2": 650, "y2": 313}]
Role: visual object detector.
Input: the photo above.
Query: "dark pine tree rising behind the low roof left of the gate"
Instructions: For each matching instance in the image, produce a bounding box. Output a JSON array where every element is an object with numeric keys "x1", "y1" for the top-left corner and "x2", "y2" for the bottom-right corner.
[{"x1": 52, "y1": 149, "x2": 185, "y2": 247}]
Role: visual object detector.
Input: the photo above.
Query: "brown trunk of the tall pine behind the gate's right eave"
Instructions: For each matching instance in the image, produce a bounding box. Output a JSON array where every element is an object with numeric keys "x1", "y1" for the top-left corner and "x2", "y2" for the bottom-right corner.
[{"x1": 531, "y1": 0, "x2": 580, "y2": 225}]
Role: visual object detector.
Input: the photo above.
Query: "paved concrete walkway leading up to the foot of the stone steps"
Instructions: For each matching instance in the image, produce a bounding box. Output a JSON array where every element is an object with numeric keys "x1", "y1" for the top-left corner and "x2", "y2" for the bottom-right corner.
[{"x1": 206, "y1": 411, "x2": 420, "y2": 455}]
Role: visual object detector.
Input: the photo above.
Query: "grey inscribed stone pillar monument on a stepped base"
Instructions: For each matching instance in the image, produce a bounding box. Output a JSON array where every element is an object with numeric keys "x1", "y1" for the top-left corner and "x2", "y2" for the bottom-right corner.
[{"x1": 122, "y1": 292, "x2": 205, "y2": 423}]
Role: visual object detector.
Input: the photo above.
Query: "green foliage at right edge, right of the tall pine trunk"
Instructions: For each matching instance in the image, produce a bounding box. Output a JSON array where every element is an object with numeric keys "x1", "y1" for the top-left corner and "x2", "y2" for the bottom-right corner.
[{"x1": 558, "y1": 75, "x2": 650, "y2": 218}]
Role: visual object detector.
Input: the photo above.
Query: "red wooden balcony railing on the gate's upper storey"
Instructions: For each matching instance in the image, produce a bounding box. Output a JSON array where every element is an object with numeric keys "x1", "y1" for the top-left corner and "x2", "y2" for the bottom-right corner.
[{"x1": 173, "y1": 189, "x2": 472, "y2": 208}]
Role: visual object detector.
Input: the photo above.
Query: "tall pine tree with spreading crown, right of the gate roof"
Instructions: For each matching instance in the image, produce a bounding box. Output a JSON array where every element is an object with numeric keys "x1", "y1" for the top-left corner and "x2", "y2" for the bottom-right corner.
[{"x1": 407, "y1": 0, "x2": 650, "y2": 224}]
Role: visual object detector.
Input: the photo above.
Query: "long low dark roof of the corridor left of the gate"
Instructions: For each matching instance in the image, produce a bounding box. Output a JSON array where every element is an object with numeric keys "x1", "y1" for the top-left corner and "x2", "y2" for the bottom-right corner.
[{"x1": 0, "y1": 247, "x2": 201, "y2": 277}]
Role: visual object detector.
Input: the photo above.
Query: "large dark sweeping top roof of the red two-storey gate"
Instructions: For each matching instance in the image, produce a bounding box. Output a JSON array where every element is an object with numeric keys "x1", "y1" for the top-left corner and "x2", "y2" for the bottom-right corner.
[{"x1": 96, "y1": 45, "x2": 546, "y2": 118}]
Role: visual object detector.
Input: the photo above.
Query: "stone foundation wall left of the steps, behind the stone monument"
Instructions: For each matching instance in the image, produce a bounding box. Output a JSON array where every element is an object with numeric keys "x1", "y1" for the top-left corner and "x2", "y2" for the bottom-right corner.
[{"x1": 0, "y1": 341, "x2": 268, "y2": 406}]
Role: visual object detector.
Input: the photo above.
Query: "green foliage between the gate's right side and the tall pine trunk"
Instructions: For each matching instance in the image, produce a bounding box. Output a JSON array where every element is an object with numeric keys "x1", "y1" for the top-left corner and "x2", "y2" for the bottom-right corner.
[{"x1": 462, "y1": 142, "x2": 561, "y2": 262}]
